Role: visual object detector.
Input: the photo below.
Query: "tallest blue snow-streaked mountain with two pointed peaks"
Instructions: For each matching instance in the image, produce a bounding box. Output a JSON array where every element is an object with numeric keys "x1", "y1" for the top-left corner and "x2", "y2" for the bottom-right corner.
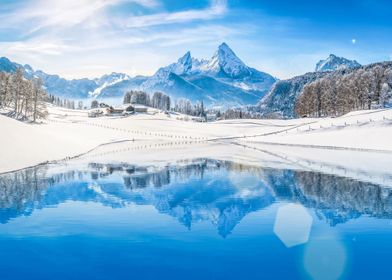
[{"x1": 140, "y1": 43, "x2": 276, "y2": 106}]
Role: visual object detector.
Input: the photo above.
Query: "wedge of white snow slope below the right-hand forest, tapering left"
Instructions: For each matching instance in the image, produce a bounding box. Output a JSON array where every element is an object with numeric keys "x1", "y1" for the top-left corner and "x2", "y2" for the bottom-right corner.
[{"x1": 243, "y1": 109, "x2": 392, "y2": 151}]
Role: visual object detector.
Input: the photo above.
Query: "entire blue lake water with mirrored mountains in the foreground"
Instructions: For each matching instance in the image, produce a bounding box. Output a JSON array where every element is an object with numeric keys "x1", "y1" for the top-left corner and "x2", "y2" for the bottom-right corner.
[{"x1": 0, "y1": 159, "x2": 392, "y2": 280}]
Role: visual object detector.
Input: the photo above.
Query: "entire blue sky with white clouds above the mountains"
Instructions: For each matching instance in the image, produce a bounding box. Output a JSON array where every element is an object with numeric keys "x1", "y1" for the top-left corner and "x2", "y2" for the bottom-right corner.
[{"x1": 0, "y1": 0, "x2": 392, "y2": 79}]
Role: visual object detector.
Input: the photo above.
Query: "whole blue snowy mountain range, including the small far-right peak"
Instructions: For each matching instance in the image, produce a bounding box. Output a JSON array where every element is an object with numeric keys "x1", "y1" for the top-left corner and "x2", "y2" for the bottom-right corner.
[{"x1": 0, "y1": 49, "x2": 361, "y2": 112}]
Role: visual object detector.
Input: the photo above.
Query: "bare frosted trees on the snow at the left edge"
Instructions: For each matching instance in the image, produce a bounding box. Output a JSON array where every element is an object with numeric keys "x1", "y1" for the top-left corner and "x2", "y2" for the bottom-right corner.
[{"x1": 0, "y1": 68, "x2": 48, "y2": 121}]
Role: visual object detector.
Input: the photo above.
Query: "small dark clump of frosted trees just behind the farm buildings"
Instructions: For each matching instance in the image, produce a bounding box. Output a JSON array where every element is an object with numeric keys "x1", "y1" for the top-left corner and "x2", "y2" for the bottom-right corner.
[{"x1": 123, "y1": 90, "x2": 171, "y2": 111}]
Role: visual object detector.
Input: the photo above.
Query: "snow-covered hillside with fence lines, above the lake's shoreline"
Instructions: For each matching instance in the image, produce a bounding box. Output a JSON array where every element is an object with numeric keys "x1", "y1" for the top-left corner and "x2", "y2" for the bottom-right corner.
[{"x1": 0, "y1": 106, "x2": 392, "y2": 173}]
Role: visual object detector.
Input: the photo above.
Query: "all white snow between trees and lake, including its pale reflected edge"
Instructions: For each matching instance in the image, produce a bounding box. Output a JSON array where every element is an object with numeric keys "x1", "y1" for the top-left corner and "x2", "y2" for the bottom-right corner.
[{"x1": 0, "y1": 106, "x2": 392, "y2": 175}]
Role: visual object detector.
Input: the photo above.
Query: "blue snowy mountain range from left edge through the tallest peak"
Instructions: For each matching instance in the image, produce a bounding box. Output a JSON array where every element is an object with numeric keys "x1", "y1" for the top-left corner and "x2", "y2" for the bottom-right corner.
[{"x1": 0, "y1": 43, "x2": 276, "y2": 107}]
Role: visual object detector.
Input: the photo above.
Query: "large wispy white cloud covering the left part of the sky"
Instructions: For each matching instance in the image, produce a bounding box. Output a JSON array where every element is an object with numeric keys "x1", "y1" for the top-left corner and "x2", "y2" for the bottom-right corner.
[{"x1": 0, "y1": 0, "x2": 231, "y2": 78}]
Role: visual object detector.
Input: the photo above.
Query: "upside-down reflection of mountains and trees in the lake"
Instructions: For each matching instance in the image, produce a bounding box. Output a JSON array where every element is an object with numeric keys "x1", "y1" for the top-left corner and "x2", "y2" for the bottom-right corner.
[{"x1": 0, "y1": 159, "x2": 392, "y2": 237}]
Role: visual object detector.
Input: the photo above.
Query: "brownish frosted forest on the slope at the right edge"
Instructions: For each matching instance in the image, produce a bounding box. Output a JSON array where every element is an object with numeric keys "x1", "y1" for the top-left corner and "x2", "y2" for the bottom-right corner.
[{"x1": 295, "y1": 63, "x2": 392, "y2": 117}]
